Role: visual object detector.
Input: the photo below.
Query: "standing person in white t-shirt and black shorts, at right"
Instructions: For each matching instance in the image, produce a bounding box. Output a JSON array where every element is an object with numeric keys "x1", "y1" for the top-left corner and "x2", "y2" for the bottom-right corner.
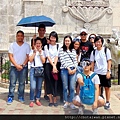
[{"x1": 90, "y1": 36, "x2": 111, "y2": 109}]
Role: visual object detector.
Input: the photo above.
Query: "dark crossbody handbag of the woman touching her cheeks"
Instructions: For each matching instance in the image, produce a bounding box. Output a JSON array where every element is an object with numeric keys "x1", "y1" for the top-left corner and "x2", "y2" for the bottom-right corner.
[{"x1": 34, "y1": 60, "x2": 44, "y2": 77}]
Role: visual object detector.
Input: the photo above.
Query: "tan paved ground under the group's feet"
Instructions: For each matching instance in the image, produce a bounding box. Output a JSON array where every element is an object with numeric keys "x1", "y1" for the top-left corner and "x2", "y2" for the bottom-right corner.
[{"x1": 0, "y1": 89, "x2": 120, "y2": 115}]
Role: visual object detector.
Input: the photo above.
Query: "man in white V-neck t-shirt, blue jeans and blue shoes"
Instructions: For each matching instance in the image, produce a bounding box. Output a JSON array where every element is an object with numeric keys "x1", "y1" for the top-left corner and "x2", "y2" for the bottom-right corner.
[{"x1": 7, "y1": 30, "x2": 30, "y2": 104}]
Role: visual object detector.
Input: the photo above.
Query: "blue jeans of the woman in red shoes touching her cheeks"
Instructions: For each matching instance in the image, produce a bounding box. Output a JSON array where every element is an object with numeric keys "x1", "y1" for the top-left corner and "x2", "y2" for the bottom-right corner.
[{"x1": 30, "y1": 67, "x2": 43, "y2": 101}]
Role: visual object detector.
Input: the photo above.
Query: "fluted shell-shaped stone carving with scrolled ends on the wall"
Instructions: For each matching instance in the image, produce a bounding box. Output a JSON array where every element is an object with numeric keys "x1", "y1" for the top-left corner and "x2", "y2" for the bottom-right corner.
[{"x1": 62, "y1": 0, "x2": 112, "y2": 29}]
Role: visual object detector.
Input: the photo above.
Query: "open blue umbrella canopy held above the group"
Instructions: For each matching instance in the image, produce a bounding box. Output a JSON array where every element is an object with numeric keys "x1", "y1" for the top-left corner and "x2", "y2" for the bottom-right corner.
[{"x1": 17, "y1": 15, "x2": 55, "y2": 27}]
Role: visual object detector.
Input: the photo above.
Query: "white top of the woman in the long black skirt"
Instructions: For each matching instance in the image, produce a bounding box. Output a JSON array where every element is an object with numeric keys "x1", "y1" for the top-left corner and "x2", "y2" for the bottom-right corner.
[{"x1": 44, "y1": 44, "x2": 60, "y2": 63}]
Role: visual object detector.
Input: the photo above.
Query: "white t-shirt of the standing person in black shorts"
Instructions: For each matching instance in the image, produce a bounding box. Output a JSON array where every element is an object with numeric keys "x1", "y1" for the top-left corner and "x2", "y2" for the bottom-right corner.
[{"x1": 90, "y1": 47, "x2": 111, "y2": 75}]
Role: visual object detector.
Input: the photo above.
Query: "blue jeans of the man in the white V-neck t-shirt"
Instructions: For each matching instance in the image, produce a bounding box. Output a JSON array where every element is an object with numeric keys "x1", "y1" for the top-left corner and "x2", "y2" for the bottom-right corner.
[{"x1": 8, "y1": 66, "x2": 28, "y2": 99}]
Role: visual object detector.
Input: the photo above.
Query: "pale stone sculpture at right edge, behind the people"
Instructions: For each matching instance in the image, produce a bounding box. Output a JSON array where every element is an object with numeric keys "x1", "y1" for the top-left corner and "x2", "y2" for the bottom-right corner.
[{"x1": 105, "y1": 29, "x2": 120, "y2": 64}]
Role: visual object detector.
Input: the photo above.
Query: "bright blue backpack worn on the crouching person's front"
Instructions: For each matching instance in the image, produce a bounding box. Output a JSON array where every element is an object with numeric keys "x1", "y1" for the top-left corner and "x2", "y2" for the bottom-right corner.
[{"x1": 80, "y1": 73, "x2": 96, "y2": 105}]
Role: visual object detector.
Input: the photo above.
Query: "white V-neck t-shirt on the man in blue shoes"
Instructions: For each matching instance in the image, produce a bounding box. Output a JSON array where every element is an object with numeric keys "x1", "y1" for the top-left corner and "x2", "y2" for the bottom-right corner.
[{"x1": 9, "y1": 42, "x2": 30, "y2": 66}]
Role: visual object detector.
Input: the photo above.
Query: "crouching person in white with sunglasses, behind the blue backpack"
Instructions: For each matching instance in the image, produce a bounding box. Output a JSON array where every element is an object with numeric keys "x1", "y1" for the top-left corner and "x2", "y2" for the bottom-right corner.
[{"x1": 73, "y1": 59, "x2": 104, "y2": 114}]
